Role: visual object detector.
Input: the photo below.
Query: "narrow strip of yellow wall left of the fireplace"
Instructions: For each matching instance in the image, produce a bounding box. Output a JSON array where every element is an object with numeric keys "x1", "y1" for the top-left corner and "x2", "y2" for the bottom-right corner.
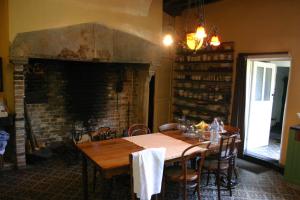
[{"x1": 0, "y1": 0, "x2": 13, "y2": 110}]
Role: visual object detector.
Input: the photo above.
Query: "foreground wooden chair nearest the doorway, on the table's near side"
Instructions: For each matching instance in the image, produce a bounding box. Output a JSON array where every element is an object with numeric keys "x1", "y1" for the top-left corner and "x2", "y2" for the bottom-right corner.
[{"x1": 203, "y1": 134, "x2": 237, "y2": 199}]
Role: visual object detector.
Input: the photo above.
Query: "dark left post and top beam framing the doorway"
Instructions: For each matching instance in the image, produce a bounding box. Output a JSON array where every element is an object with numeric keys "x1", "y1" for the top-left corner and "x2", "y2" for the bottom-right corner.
[{"x1": 231, "y1": 52, "x2": 292, "y2": 158}]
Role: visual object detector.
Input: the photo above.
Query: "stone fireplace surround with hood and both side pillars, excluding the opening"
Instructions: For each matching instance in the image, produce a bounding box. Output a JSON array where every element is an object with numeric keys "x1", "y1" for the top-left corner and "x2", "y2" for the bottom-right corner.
[{"x1": 10, "y1": 24, "x2": 161, "y2": 168}]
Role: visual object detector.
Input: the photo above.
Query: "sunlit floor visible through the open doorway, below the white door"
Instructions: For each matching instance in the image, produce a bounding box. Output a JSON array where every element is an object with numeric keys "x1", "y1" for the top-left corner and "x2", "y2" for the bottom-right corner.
[{"x1": 247, "y1": 139, "x2": 280, "y2": 160}]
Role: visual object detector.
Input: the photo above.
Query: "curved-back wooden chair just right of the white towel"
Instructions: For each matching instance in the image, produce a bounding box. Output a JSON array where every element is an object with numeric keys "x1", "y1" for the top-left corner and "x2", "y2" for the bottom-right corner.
[{"x1": 163, "y1": 141, "x2": 210, "y2": 200}]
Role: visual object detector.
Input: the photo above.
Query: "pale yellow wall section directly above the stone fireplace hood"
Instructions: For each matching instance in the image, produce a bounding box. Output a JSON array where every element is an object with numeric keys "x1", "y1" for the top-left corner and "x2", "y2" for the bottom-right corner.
[{"x1": 9, "y1": 0, "x2": 162, "y2": 42}]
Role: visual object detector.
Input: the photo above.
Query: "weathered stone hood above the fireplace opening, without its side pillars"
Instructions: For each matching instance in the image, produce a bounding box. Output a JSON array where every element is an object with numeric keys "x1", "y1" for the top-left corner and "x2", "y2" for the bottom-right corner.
[{"x1": 10, "y1": 23, "x2": 160, "y2": 66}]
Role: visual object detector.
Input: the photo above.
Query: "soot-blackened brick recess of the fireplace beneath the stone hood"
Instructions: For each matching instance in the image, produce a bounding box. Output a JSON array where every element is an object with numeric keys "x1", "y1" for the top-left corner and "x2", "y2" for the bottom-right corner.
[{"x1": 24, "y1": 59, "x2": 149, "y2": 146}]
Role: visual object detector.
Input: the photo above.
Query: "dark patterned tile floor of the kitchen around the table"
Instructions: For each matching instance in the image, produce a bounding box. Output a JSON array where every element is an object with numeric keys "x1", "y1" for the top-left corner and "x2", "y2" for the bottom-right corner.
[{"x1": 0, "y1": 155, "x2": 300, "y2": 200}]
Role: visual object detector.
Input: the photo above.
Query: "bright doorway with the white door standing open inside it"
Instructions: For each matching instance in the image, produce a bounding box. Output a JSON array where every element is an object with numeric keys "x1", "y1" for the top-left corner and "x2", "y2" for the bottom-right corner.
[{"x1": 244, "y1": 55, "x2": 291, "y2": 164}]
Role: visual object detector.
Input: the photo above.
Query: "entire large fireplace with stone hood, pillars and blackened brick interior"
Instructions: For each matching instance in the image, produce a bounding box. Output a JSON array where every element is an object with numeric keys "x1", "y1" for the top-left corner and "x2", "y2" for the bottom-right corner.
[{"x1": 10, "y1": 24, "x2": 160, "y2": 168}]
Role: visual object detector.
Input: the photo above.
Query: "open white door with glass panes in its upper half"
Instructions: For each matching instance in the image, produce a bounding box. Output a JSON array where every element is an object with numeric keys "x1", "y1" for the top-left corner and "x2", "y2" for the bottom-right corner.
[{"x1": 246, "y1": 61, "x2": 276, "y2": 149}]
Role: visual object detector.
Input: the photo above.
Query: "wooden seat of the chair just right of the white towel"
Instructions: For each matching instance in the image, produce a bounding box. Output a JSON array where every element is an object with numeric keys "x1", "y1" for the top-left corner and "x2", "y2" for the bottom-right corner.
[{"x1": 164, "y1": 166, "x2": 198, "y2": 182}]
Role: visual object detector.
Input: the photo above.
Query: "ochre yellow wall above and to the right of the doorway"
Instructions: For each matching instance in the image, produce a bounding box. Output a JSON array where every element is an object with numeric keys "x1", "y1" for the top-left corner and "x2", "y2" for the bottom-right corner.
[{"x1": 181, "y1": 0, "x2": 300, "y2": 164}]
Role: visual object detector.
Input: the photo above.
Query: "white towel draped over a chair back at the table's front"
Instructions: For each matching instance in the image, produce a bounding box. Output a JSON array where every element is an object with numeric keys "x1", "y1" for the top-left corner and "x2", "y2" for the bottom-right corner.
[{"x1": 132, "y1": 148, "x2": 166, "y2": 200}]
